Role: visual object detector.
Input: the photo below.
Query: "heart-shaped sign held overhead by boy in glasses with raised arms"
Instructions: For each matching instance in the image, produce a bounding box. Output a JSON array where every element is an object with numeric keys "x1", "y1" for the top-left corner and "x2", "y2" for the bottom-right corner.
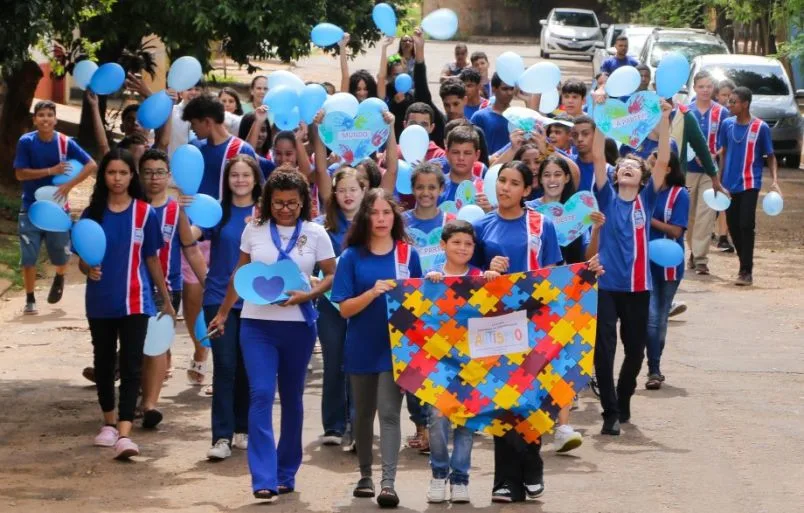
[{"x1": 594, "y1": 91, "x2": 662, "y2": 148}]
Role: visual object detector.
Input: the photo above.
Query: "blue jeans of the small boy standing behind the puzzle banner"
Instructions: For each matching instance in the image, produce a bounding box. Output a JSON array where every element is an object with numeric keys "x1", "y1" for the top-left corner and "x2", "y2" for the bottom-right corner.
[{"x1": 429, "y1": 408, "x2": 472, "y2": 485}]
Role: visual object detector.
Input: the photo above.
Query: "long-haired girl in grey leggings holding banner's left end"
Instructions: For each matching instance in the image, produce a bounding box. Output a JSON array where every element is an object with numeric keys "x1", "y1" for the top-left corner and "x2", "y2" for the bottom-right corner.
[{"x1": 332, "y1": 189, "x2": 422, "y2": 507}]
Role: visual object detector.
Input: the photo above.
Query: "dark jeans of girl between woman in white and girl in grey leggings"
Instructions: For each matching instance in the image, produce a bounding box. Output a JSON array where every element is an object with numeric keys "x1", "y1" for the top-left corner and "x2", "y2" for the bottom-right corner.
[{"x1": 318, "y1": 298, "x2": 354, "y2": 434}]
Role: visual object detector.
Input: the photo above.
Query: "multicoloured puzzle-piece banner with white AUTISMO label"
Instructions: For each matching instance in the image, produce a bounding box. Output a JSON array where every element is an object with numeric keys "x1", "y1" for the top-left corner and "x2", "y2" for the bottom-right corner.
[{"x1": 386, "y1": 264, "x2": 597, "y2": 443}]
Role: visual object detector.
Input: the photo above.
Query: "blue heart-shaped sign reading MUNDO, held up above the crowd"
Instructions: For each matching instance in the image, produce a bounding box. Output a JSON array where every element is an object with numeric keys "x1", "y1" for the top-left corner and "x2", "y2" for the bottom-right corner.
[{"x1": 318, "y1": 104, "x2": 390, "y2": 164}]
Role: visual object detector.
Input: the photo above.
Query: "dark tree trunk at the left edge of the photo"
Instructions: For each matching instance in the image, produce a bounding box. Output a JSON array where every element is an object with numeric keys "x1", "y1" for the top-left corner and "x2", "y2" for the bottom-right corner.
[{"x1": 0, "y1": 61, "x2": 43, "y2": 185}]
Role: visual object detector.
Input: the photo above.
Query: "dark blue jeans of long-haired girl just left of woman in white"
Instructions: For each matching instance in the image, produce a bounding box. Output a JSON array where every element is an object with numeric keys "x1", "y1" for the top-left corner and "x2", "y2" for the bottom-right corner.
[{"x1": 204, "y1": 305, "x2": 249, "y2": 445}]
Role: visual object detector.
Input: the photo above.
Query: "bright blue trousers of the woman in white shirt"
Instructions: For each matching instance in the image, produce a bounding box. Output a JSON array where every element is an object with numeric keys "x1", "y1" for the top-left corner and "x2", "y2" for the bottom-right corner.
[{"x1": 240, "y1": 319, "x2": 316, "y2": 492}]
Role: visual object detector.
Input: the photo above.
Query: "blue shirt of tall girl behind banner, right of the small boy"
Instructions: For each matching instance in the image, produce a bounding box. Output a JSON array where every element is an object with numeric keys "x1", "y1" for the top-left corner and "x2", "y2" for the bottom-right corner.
[{"x1": 472, "y1": 210, "x2": 562, "y2": 273}]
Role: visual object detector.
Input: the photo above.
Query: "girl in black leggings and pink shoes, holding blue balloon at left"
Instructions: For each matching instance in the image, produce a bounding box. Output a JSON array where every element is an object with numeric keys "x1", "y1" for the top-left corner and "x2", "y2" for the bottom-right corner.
[{"x1": 76, "y1": 150, "x2": 176, "y2": 459}]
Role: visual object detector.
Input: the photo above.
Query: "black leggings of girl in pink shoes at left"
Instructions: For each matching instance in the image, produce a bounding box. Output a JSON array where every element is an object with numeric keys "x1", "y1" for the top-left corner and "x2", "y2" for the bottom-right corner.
[{"x1": 88, "y1": 314, "x2": 148, "y2": 422}]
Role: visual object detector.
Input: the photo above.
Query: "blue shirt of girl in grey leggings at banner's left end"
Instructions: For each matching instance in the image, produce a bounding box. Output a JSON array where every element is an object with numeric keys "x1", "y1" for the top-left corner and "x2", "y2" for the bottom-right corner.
[{"x1": 331, "y1": 242, "x2": 422, "y2": 374}]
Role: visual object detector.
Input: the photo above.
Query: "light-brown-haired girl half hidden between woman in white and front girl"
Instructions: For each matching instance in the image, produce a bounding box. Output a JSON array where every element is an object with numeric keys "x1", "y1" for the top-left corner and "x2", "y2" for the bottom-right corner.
[{"x1": 316, "y1": 166, "x2": 368, "y2": 451}]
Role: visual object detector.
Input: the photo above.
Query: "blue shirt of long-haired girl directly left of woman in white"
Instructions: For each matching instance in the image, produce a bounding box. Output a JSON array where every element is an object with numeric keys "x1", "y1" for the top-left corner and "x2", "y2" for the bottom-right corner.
[{"x1": 203, "y1": 205, "x2": 254, "y2": 310}]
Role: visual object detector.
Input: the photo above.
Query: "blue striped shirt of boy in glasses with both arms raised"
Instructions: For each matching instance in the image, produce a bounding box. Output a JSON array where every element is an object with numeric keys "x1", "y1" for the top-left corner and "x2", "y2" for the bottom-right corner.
[{"x1": 595, "y1": 178, "x2": 657, "y2": 292}]
